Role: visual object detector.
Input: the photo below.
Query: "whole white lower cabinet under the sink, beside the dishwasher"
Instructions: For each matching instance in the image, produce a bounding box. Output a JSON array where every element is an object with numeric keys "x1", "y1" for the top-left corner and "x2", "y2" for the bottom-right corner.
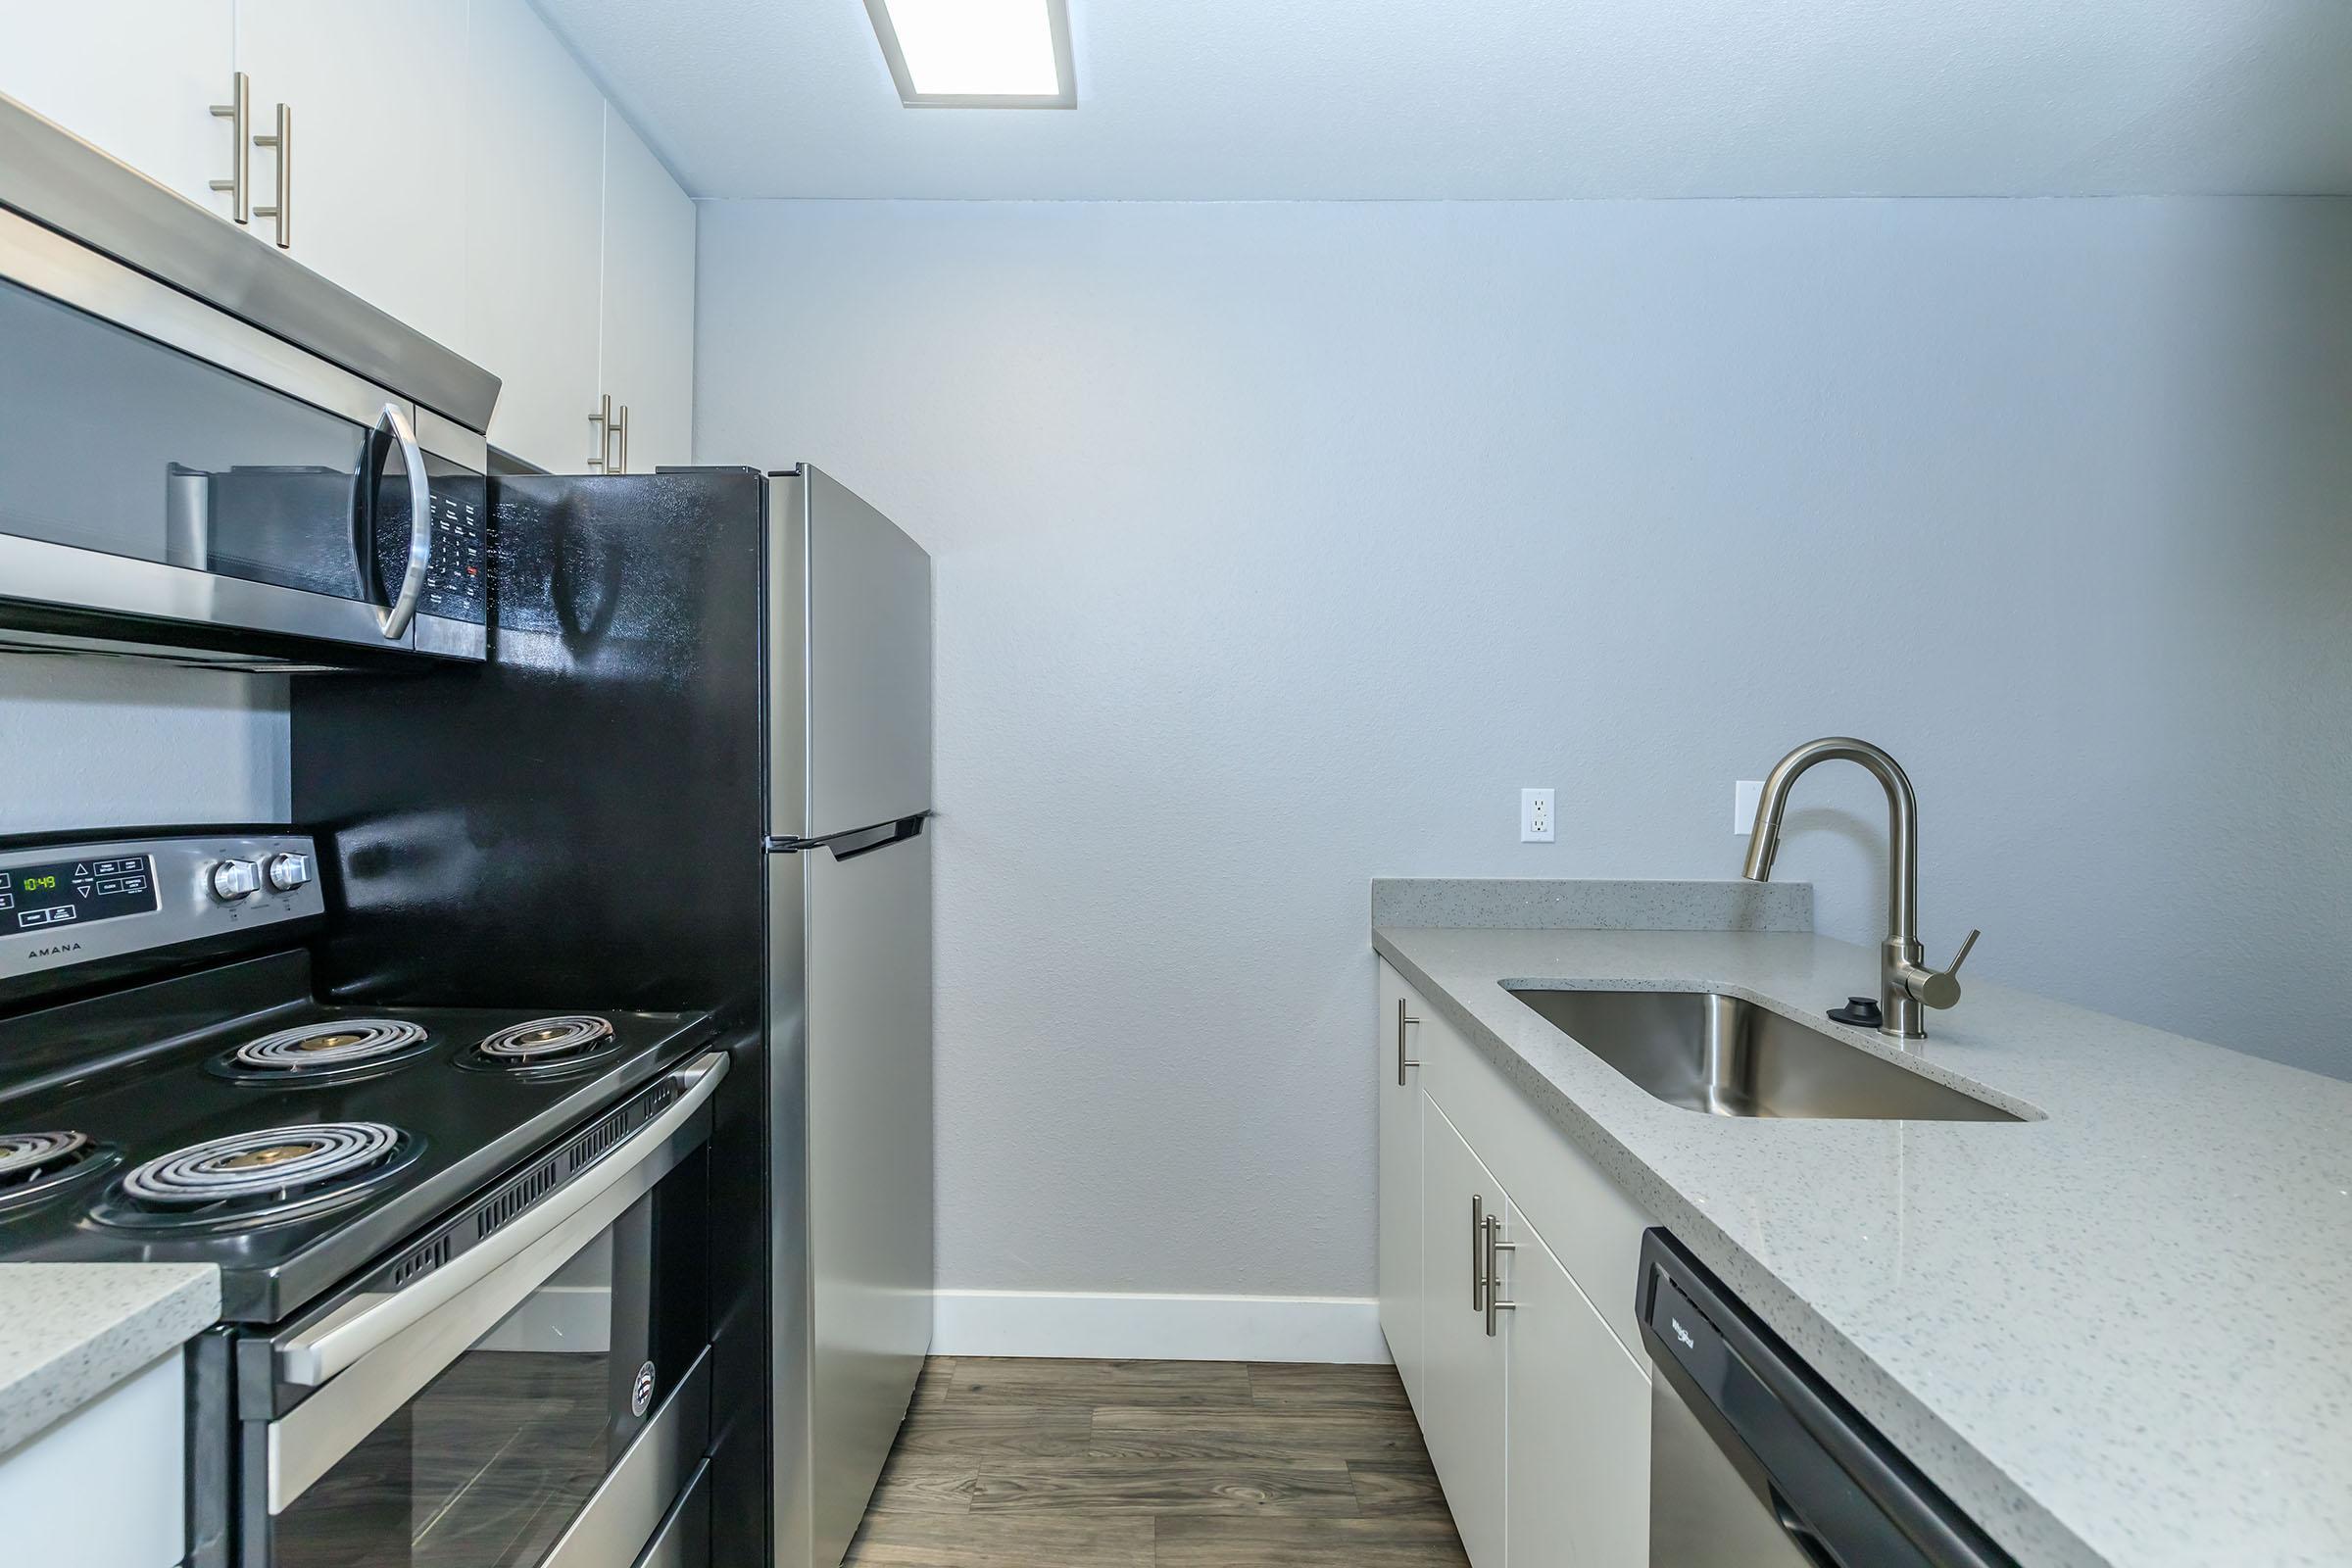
[{"x1": 1378, "y1": 961, "x2": 1651, "y2": 1568}]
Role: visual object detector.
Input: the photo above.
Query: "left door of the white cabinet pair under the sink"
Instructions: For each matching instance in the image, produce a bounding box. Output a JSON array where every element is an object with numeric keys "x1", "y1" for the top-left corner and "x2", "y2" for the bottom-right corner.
[{"x1": 1416, "y1": 1096, "x2": 1507, "y2": 1568}]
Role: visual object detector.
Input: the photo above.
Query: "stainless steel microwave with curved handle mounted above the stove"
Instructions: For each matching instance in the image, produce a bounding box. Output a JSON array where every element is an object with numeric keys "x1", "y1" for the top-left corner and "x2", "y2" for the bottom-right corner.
[{"x1": 0, "y1": 214, "x2": 489, "y2": 665}]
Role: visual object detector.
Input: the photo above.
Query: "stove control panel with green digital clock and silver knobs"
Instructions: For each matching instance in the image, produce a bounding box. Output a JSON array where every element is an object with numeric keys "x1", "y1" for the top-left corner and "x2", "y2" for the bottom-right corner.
[{"x1": 0, "y1": 832, "x2": 327, "y2": 983}]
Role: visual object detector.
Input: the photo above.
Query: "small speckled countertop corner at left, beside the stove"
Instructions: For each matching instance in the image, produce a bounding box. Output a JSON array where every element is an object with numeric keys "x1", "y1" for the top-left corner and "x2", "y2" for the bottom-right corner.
[{"x1": 0, "y1": 1262, "x2": 221, "y2": 1457}]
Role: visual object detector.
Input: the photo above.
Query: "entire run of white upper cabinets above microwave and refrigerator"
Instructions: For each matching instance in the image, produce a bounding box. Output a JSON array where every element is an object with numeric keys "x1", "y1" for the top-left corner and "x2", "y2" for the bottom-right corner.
[{"x1": 0, "y1": 0, "x2": 694, "y2": 472}]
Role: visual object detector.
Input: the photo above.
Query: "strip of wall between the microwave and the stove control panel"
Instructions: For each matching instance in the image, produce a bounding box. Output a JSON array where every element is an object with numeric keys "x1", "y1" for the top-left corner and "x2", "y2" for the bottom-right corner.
[{"x1": 0, "y1": 654, "x2": 287, "y2": 832}]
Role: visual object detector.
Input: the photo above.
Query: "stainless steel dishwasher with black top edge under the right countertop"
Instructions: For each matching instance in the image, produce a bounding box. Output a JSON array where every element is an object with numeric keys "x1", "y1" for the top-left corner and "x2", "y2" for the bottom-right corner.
[{"x1": 1637, "y1": 1230, "x2": 2016, "y2": 1568}]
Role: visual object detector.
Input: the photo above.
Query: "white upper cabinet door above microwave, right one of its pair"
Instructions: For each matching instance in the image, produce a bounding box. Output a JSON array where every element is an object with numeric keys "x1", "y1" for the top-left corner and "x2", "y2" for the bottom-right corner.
[{"x1": 237, "y1": 0, "x2": 472, "y2": 346}]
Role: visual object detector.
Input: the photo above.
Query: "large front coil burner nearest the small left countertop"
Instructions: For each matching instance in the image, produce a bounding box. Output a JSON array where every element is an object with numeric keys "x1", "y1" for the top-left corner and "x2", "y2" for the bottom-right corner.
[{"x1": 92, "y1": 1121, "x2": 416, "y2": 1230}]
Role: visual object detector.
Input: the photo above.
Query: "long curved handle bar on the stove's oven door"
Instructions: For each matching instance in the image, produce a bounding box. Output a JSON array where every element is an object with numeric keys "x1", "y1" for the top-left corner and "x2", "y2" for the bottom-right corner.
[{"x1": 277, "y1": 1051, "x2": 727, "y2": 1390}]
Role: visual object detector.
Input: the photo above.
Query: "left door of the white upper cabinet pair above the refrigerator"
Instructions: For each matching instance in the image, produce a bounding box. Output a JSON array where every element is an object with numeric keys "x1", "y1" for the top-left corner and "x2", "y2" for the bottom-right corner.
[{"x1": 466, "y1": 0, "x2": 605, "y2": 472}]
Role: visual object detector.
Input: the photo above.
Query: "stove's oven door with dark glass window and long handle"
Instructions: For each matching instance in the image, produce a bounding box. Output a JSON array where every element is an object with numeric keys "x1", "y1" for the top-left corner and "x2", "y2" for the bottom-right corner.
[{"x1": 237, "y1": 1054, "x2": 727, "y2": 1568}]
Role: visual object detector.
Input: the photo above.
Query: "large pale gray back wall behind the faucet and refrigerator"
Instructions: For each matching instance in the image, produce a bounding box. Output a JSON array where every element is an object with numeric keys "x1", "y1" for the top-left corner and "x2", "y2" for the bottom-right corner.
[{"x1": 696, "y1": 200, "x2": 2352, "y2": 1296}]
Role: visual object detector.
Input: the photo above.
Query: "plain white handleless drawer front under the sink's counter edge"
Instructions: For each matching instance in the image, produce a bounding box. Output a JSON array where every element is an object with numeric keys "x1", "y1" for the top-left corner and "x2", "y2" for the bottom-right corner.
[{"x1": 1406, "y1": 987, "x2": 1653, "y2": 1363}]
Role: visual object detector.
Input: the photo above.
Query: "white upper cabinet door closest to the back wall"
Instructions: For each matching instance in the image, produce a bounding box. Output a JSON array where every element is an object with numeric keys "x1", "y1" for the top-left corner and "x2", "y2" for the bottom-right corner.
[{"x1": 598, "y1": 104, "x2": 694, "y2": 472}]
